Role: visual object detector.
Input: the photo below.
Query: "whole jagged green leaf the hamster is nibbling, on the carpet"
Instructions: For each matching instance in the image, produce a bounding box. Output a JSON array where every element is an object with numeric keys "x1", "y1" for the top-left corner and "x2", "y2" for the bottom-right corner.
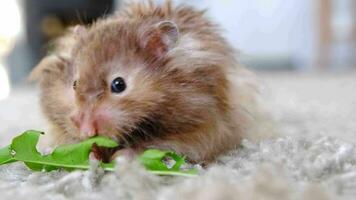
[{"x1": 0, "y1": 130, "x2": 197, "y2": 176}]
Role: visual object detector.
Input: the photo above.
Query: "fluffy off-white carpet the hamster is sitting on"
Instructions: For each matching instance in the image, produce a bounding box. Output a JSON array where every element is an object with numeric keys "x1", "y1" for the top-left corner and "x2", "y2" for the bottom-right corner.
[{"x1": 0, "y1": 73, "x2": 356, "y2": 200}]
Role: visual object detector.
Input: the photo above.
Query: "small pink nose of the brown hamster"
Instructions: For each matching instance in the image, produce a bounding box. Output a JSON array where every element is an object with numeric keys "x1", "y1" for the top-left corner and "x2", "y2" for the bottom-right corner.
[{"x1": 71, "y1": 115, "x2": 98, "y2": 137}]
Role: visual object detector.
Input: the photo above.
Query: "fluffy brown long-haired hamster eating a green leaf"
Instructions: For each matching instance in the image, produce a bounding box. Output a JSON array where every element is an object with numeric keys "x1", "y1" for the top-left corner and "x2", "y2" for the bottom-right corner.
[{"x1": 32, "y1": 2, "x2": 270, "y2": 162}]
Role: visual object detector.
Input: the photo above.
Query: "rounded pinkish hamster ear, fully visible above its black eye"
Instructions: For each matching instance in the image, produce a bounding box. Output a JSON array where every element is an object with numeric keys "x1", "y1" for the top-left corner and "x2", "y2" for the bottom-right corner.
[{"x1": 141, "y1": 21, "x2": 179, "y2": 58}]
